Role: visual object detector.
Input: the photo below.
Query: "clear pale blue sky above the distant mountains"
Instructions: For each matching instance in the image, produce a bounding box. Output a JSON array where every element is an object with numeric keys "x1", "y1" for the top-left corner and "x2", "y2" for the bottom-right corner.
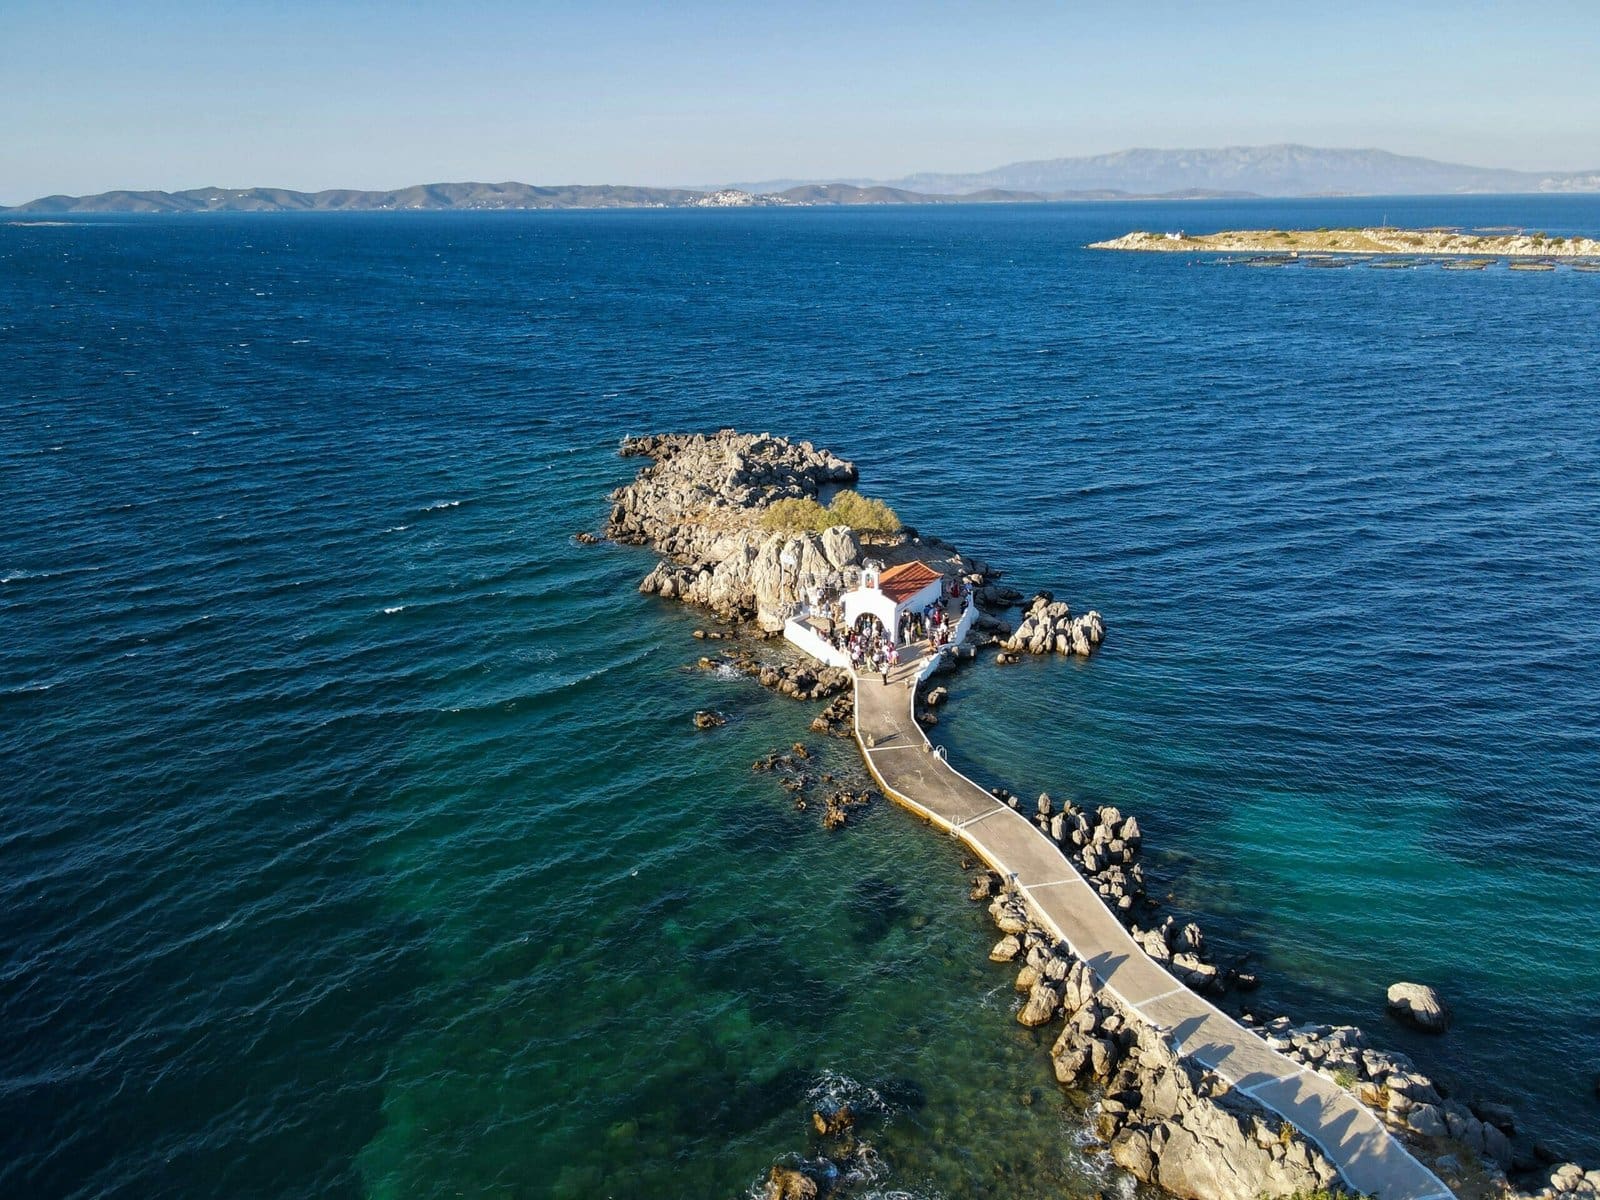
[{"x1": 0, "y1": 0, "x2": 1600, "y2": 203}]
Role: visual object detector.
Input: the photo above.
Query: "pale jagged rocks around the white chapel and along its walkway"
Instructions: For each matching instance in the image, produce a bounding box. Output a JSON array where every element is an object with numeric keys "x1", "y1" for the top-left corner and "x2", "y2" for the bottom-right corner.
[{"x1": 605, "y1": 430, "x2": 1600, "y2": 1200}]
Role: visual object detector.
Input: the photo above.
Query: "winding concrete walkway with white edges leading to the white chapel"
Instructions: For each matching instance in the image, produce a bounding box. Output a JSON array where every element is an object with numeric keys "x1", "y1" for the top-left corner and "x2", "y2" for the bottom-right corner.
[{"x1": 856, "y1": 658, "x2": 1451, "y2": 1200}]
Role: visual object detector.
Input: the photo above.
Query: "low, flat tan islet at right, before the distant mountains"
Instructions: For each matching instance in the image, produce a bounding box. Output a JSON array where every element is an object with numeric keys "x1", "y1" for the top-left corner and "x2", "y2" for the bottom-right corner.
[{"x1": 1090, "y1": 226, "x2": 1600, "y2": 258}]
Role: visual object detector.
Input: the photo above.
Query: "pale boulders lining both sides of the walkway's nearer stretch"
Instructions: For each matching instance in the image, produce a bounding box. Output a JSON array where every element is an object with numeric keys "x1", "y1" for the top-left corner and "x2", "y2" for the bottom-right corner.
[{"x1": 947, "y1": 678, "x2": 1600, "y2": 1200}]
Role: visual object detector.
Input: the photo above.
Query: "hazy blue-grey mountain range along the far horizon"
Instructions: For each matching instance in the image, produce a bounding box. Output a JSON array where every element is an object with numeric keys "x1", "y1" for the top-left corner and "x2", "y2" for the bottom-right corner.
[{"x1": 12, "y1": 146, "x2": 1600, "y2": 216}]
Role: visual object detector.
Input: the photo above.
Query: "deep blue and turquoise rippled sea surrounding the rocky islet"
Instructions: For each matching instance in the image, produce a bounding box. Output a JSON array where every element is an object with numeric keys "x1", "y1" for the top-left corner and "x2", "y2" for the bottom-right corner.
[{"x1": 0, "y1": 197, "x2": 1600, "y2": 1200}]
